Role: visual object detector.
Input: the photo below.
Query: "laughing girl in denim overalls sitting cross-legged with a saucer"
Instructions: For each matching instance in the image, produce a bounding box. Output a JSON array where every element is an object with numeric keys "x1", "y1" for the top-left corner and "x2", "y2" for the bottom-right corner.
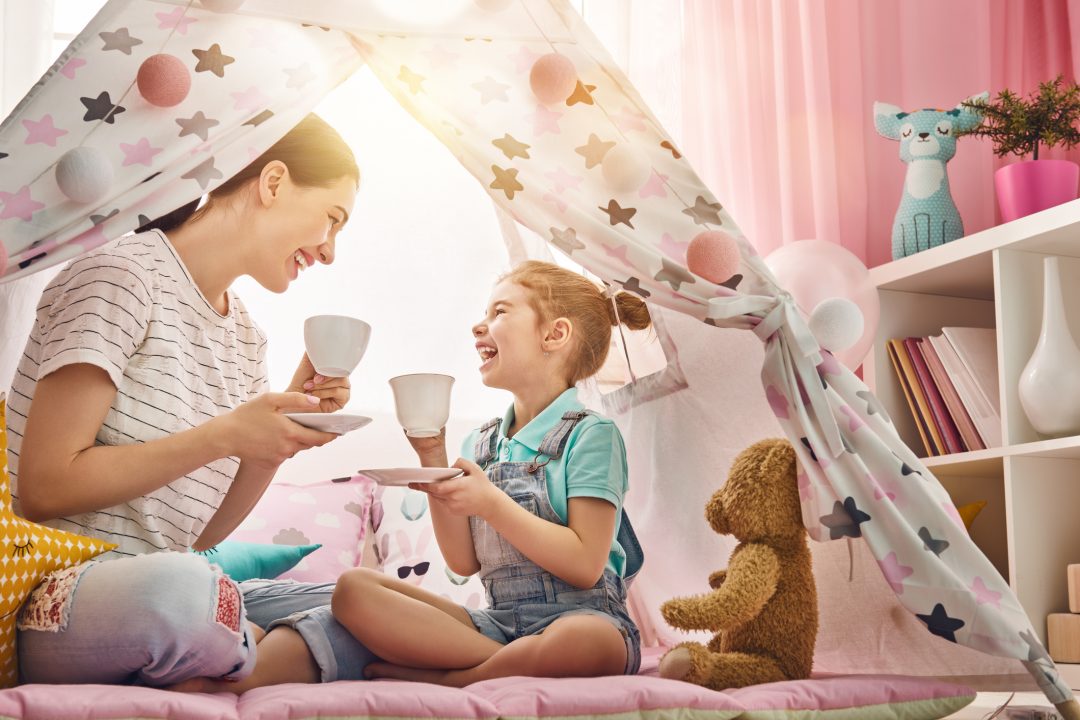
[{"x1": 332, "y1": 262, "x2": 649, "y2": 687}]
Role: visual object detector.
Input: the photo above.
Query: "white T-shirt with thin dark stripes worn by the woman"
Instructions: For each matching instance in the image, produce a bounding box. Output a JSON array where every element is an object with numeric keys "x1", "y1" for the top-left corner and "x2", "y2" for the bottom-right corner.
[{"x1": 8, "y1": 232, "x2": 267, "y2": 558}]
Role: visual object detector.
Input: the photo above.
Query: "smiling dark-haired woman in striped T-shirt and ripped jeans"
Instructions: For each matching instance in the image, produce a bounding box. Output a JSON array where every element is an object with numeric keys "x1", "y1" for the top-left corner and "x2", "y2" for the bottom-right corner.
[{"x1": 9, "y1": 116, "x2": 370, "y2": 685}]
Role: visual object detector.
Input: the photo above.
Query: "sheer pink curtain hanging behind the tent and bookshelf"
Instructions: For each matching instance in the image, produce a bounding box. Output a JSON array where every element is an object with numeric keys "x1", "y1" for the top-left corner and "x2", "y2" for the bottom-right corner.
[{"x1": 681, "y1": 0, "x2": 1080, "y2": 267}]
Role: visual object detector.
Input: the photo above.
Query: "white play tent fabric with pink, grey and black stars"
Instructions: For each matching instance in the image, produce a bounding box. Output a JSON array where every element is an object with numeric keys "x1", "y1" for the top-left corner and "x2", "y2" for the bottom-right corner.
[{"x1": 0, "y1": 0, "x2": 1072, "y2": 703}]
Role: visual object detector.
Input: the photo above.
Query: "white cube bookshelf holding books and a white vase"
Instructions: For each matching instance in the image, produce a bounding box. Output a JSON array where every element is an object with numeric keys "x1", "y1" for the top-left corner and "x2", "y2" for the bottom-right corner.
[{"x1": 863, "y1": 200, "x2": 1080, "y2": 689}]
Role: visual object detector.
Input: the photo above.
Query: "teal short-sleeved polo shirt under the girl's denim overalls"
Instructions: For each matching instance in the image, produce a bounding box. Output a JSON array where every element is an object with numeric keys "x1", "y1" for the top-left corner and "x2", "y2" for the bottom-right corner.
[{"x1": 461, "y1": 388, "x2": 627, "y2": 578}]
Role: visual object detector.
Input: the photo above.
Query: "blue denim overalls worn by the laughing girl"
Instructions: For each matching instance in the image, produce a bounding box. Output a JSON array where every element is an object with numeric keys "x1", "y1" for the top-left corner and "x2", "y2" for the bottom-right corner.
[{"x1": 469, "y1": 411, "x2": 644, "y2": 675}]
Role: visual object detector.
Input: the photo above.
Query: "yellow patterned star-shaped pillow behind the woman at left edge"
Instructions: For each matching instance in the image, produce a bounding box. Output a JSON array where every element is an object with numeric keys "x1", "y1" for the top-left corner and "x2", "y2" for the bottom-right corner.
[{"x1": 0, "y1": 393, "x2": 116, "y2": 688}]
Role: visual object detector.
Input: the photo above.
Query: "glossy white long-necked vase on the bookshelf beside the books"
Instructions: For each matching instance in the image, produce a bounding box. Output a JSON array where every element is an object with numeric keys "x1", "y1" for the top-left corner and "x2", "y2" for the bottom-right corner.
[{"x1": 1017, "y1": 256, "x2": 1080, "y2": 437}]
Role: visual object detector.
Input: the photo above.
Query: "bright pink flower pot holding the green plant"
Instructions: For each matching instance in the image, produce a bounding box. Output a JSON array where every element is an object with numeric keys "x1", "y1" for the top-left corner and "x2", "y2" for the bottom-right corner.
[{"x1": 994, "y1": 160, "x2": 1080, "y2": 222}]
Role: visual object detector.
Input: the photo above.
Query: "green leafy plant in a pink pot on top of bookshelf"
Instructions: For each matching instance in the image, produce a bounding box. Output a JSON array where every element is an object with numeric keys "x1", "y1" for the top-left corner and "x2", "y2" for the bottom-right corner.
[{"x1": 957, "y1": 76, "x2": 1080, "y2": 222}]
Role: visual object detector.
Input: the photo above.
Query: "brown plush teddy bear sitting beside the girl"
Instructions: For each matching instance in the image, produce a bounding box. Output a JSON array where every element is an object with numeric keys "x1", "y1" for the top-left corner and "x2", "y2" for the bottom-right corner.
[{"x1": 660, "y1": 438, "x2": 818, "y2": 690}]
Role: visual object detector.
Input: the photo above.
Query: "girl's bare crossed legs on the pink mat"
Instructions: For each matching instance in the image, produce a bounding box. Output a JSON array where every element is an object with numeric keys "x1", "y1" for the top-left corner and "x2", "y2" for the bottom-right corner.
[{"x1": 332, "y1": 568, "x2": 627, "y2": 688}]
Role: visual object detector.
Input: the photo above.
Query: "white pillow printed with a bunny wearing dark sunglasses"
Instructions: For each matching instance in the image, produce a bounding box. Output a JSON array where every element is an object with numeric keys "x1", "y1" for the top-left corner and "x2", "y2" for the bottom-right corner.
[{"x1": 372, "y1": 486, "x2": 487, "y2": 608}]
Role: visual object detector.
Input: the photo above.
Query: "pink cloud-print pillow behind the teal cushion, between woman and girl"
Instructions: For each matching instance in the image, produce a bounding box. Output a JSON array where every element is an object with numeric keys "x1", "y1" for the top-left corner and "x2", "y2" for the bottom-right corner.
[{"x1": 229, "y1": 476, "x2": 375, "y2": 583}]
